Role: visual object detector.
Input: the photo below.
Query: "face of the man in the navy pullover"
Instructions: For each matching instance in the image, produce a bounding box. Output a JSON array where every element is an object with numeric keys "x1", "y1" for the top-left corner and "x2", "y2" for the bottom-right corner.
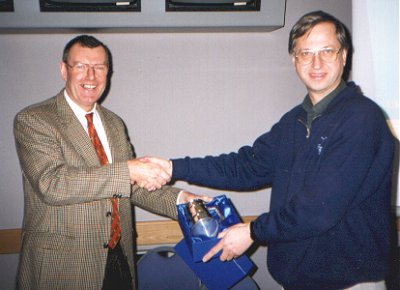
[{"x1": 292, "y1": 22, "x2": 347, "y2": 105}]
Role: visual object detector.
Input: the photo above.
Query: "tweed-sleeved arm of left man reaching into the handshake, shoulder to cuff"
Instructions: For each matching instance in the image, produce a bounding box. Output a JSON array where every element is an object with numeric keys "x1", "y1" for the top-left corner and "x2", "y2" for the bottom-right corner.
[{"x1": 14, "y1": 113, "x2": 131, "y2": 205}]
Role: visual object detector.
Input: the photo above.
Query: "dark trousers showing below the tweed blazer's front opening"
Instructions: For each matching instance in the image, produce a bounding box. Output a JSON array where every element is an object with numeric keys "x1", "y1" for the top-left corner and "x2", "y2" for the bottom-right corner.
[{"x1": 102, "y1": 243, "x2": 133, "y2": 290}]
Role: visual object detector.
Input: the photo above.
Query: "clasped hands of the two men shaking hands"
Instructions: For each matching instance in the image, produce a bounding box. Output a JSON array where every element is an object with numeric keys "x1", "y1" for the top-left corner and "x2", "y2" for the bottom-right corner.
[{"x1": 128, "y1": 157, "x2": 172, "y2": 191}]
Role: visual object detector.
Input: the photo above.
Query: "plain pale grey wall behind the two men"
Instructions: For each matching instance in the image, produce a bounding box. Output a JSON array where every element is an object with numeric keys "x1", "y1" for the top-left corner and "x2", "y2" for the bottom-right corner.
[{"x1": 0, "y1": 0, "x2": 351, "y2": 290}]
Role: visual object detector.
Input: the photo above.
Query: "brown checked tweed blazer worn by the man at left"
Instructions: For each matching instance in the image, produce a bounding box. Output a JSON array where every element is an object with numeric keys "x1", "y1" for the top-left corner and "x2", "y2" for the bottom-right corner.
[{"x1": 14, "y1": 90, "x2": 179, "y2": 290}]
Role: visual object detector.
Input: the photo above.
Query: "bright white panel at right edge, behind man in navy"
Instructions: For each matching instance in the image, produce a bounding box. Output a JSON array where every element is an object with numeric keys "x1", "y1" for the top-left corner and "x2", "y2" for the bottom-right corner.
[{"x1": 353, "y1": 0, "x2": 400, "y2": 207}]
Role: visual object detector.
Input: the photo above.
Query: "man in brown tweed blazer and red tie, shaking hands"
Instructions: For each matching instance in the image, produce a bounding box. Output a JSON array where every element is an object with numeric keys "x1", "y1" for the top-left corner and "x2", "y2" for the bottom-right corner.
[{"x1": 14, "y1": 35, "x2": 211, "y2": 290}]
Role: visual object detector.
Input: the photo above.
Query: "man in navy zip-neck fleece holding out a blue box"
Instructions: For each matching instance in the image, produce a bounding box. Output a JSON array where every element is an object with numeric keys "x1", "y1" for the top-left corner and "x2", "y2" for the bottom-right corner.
[{"x1": 148, "y1": 11, "x2": 394, "y2": 290}]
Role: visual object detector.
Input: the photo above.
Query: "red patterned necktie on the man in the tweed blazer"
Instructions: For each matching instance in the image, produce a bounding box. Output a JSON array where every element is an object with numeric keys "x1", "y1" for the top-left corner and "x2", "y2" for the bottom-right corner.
[{"x1": 86, "y1": 113, "x2": 121, "y2": 249}]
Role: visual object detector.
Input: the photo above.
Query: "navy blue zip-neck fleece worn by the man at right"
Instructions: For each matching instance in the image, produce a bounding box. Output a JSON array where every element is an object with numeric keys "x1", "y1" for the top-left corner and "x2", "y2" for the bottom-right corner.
[{"x1": 172, "y1": 82, "x2": 394, "y2": 290}]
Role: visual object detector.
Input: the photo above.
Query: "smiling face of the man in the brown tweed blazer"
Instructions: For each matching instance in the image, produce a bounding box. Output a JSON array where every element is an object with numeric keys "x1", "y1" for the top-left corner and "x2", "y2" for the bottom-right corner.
[{"x1": 60, "y1": 43, "x2": 107, "y2": 111}]
